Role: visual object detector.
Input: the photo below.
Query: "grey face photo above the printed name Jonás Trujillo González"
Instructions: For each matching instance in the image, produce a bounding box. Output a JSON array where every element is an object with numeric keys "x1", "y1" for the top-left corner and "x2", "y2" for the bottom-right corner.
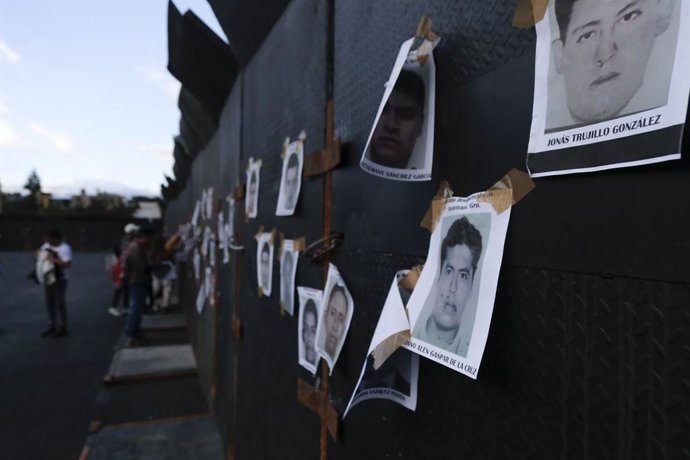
[{"x1": 546, "y1": 0, "x2": 678, "y2": 131}]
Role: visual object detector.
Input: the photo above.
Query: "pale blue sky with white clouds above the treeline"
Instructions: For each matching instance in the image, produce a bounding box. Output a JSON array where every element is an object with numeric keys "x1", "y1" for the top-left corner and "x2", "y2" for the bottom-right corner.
[{"x1": 0, "y1": 0, "x2": 227, "y2": 197}]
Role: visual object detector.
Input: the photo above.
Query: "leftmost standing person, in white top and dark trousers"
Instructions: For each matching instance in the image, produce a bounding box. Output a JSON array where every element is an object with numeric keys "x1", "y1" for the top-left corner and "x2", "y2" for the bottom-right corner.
[{"x1": 40, "y1": 230, "x2": 72, "y2": 337}]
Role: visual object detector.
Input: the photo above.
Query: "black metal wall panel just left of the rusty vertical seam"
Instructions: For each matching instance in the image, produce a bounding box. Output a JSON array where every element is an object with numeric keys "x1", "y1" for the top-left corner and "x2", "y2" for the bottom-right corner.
[{"x1": 236, "y1": 0, "x2": 327, "y2": 458}]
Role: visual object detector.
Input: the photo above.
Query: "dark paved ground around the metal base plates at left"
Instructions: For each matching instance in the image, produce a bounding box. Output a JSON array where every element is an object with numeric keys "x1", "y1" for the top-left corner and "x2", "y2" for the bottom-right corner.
[{"x1": 0, "y1": 253, "x2": 208, "y2": 460}]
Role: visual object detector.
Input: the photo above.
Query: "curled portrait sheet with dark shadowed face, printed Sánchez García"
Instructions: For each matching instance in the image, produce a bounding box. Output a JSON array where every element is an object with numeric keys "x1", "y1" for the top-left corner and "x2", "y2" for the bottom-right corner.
[{"x1": 360, "y1": 33, "x2": 436, "y2": 181}]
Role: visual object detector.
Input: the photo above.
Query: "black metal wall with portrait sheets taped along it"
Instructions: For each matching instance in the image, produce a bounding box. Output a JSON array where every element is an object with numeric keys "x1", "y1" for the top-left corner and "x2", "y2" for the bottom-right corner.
[{"x1": 166, "y1": 0, "x2": 690, "y2": 459}]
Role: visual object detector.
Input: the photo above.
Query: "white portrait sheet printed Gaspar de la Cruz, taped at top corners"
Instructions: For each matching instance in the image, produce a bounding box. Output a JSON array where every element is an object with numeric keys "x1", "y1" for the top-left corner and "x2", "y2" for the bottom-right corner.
[{"x1": 406, "y1": 190, "x2": 512, "y2": 378}]
